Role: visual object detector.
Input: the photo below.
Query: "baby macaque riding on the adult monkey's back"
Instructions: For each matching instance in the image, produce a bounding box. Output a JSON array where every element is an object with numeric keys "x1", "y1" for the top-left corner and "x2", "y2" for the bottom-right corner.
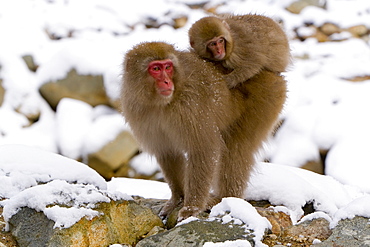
[{"x1": 189, "y1": 15, "x2": 290, "y2": 88}]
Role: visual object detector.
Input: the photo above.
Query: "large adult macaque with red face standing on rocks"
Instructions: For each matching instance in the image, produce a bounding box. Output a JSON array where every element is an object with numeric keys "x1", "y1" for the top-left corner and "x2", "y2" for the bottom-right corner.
[{"x1": 121, "y1": 42, "x2": 286, "y2": 221}]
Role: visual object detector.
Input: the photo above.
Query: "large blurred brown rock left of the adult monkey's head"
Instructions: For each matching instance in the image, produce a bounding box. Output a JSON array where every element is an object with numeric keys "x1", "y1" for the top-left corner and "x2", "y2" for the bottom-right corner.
[{"x1": 39, "y1": 69, "x2": 110, "y2": 110}]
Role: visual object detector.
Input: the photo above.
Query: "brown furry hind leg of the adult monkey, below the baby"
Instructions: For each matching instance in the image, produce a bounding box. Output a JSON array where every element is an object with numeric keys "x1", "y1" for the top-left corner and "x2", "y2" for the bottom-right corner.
[{"x1": 212, "y1": 70, "x2": 286, "y2": 203}]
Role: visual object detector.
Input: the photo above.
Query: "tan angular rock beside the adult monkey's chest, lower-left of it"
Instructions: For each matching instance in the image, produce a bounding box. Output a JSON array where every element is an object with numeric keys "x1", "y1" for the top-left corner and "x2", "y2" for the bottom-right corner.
[{"x1": 87, "y1": 131, "x2": 139, "y2": 179}]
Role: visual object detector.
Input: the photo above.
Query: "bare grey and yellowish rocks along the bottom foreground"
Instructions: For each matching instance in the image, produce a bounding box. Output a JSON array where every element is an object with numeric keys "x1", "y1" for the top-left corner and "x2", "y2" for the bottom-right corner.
[{"x1": 0, "y1": 195, "x2": 370, "y2": 247}]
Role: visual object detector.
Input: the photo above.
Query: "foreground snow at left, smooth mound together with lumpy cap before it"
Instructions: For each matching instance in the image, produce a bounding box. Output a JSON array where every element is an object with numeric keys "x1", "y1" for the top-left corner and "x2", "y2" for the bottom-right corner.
[{"x1": 0, "y1": 145, "x2": 132, "y2": 228}]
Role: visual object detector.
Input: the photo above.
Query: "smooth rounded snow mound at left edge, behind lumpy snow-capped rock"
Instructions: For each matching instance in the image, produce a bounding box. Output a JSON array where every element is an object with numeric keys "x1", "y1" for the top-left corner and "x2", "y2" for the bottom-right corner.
[{"x1": 0, "y1": 145, "x2": 107, "y2": 191}]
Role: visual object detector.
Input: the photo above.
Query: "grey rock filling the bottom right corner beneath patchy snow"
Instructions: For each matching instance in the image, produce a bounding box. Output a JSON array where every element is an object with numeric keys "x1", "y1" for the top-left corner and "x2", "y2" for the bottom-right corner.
[{"x1": 315, "y1": 216, "x2": 370, "y2": 247}]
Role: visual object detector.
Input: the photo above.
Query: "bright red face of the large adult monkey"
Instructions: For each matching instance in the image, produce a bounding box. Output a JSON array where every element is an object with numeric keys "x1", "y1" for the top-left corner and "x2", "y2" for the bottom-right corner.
[{"x1": 148, "y1": 59, "x2": 174, "y2": 97}]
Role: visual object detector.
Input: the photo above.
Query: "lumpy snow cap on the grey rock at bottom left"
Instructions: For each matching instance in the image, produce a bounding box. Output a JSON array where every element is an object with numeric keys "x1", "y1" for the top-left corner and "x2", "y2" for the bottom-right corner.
[{"x1": 3, "y1": 180, "x2": 105, "y2": 228}]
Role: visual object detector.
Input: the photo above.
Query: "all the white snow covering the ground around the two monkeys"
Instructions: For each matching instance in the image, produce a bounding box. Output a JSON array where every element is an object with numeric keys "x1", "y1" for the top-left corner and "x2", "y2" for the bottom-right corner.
[{"x1": 0, "y1": 0, "x2": 370, "y2": 246}]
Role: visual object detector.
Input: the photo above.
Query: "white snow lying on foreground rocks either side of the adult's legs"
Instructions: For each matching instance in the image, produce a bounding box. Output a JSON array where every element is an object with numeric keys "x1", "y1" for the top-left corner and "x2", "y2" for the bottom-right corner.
[{"x1": 0, "y1": 145, "x2": 370, "y2": 246}]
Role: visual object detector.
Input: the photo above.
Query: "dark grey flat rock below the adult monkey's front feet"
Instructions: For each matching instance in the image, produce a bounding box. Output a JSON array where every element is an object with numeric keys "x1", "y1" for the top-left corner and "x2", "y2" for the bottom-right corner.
[{"x1": 136, "y1": 220, "x2": 254, "y2": 247}]
